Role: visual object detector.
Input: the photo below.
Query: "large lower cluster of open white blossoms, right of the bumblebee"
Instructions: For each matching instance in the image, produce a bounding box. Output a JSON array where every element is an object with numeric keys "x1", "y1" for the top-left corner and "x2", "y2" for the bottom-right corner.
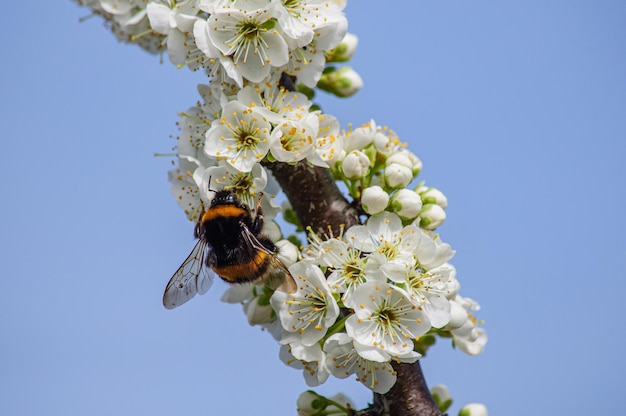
[{"x1": 262, "y1": 212, "x2": 486, "y2": 393}]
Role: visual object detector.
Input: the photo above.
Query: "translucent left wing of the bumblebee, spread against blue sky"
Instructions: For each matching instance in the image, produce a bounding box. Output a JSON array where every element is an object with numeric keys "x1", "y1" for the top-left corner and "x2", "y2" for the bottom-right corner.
[{"x1": 163, "y1": 240, "x2": 213, "y2": 309}]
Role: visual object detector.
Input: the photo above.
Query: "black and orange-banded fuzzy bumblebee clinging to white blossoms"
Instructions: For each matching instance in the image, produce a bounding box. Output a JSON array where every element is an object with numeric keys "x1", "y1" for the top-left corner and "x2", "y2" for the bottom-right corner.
[{"x1": 163, "y1": 190, "x2": 296, "y2": 309}]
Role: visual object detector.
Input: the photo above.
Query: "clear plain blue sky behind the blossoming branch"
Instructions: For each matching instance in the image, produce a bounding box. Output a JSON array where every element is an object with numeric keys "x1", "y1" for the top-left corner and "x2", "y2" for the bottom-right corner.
[{"x1": 0, "y1": 0, "x2": 626, "y2": 416}]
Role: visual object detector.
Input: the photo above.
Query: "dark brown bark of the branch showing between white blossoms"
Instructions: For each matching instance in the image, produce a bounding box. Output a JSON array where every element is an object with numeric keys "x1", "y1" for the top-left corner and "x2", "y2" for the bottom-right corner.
[{"x1": 267, "y1": 161, "x2": 441, "y2": 416}]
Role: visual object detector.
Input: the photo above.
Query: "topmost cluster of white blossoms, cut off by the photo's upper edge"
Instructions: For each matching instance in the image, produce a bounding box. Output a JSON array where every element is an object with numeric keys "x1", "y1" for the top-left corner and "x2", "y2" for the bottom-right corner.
[{"x1": 75, "y1": 0, "x2": 359, "y2": 82}]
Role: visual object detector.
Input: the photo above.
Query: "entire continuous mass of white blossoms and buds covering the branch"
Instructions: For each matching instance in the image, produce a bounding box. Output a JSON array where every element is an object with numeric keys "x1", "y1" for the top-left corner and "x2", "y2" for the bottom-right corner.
[{"x1": 76, "y1": 0, "x2": 487, "y2": 393}]
